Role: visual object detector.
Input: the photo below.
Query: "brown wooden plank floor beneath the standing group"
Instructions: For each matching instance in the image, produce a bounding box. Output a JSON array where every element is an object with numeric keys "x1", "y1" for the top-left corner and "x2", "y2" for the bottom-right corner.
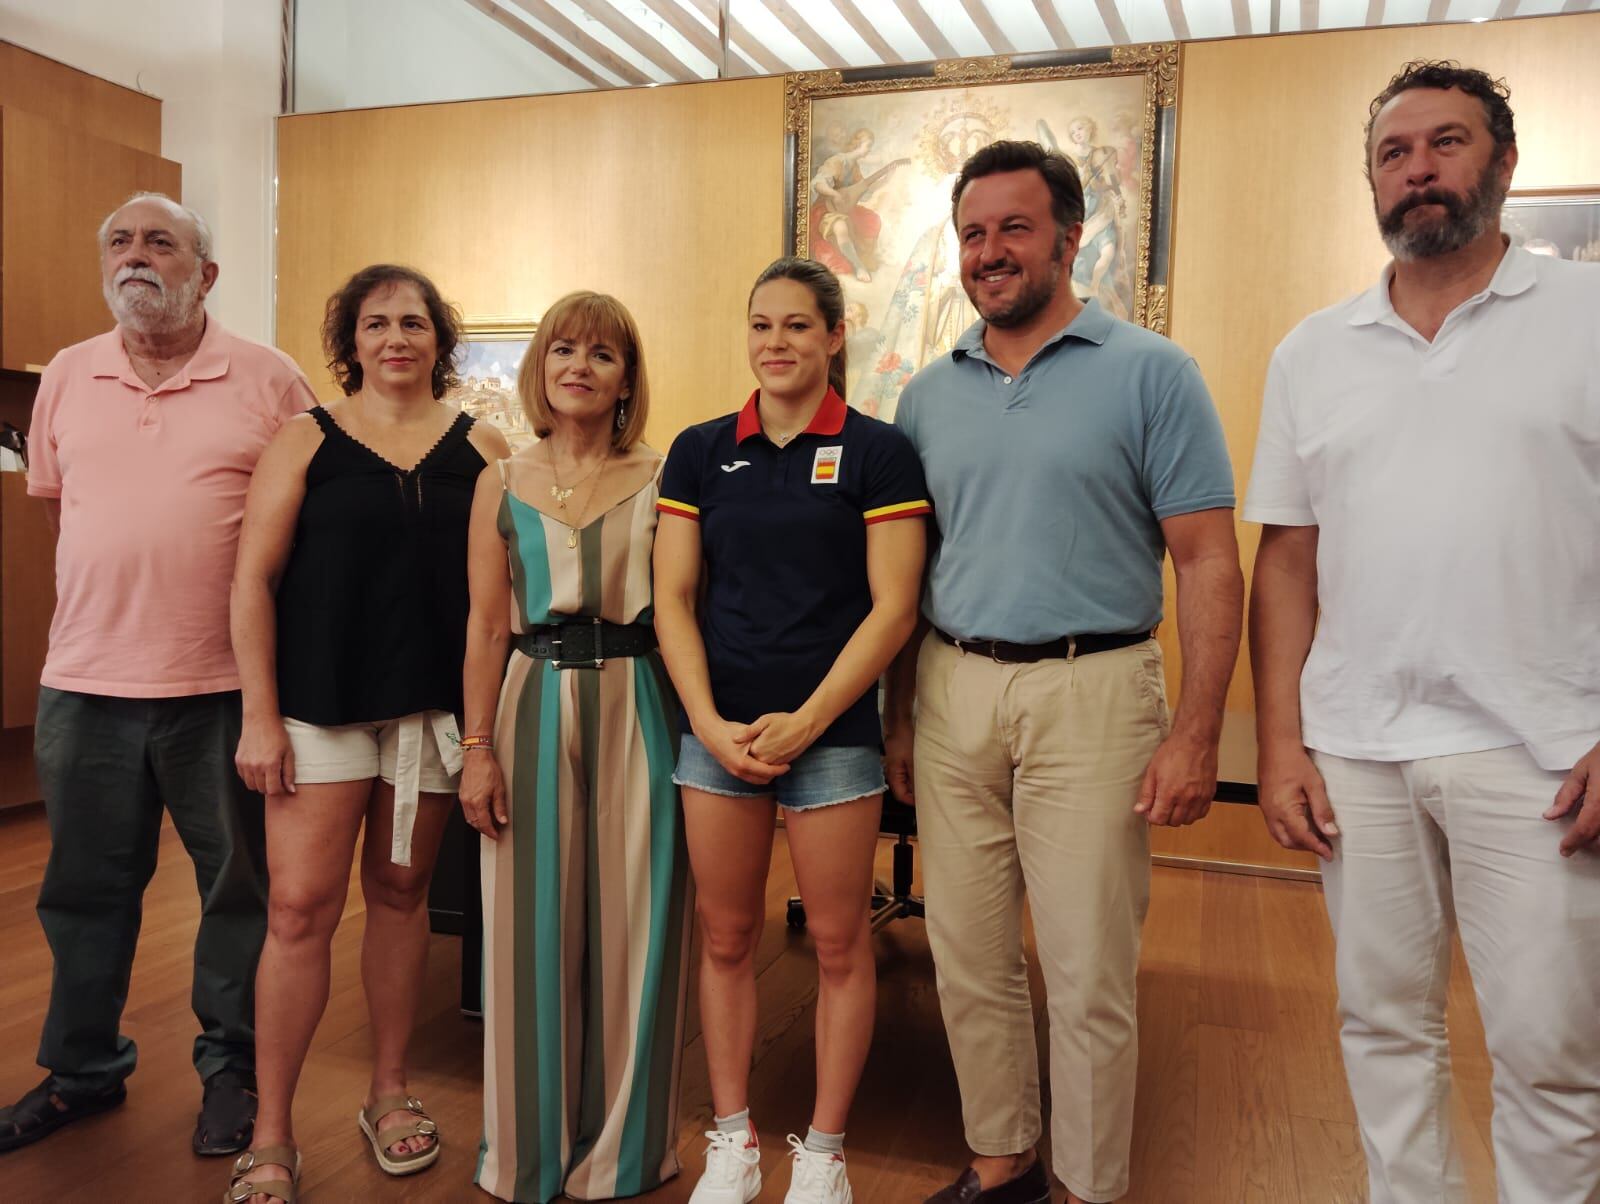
[{"x1": 0, "y1": 809, "x2": 1494, "y2": 1204}]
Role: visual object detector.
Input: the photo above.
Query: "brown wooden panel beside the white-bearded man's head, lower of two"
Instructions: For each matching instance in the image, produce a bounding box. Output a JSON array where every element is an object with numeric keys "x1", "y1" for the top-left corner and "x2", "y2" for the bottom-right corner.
[{"x1": 0, "y1": 109, "x2": 182, "y2": 368}]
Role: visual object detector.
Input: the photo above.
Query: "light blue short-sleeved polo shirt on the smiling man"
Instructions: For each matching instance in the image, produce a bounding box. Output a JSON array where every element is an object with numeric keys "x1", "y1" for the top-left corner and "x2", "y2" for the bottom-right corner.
[{"x1": 894, "y1": 301, "x2": 1234, "y2": 644}]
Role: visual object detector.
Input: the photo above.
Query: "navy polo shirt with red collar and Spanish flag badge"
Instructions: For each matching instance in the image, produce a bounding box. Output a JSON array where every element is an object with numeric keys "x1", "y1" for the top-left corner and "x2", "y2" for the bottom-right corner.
[{"x1": 656, "y1": 389, "x2": 933, "y2": 746}]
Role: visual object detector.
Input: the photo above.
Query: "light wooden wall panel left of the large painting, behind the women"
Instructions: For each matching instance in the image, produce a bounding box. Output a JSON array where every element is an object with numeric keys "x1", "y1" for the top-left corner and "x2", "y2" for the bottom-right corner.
[{"x1": 277, "y1": 80, "x2": 784, "y2": 450}]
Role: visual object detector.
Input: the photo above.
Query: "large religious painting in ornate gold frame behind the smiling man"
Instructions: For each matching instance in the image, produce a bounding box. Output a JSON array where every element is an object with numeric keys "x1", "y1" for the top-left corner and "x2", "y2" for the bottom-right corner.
[{"x1": 786, "y1": 42, "x2": 1181, "y2": 418}]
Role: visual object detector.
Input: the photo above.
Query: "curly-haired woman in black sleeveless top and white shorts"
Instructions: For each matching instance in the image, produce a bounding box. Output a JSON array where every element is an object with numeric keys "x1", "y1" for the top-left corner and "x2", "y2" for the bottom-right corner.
[{"x1": 230, "y1": 264, "x2": 510, "y2": 1204}]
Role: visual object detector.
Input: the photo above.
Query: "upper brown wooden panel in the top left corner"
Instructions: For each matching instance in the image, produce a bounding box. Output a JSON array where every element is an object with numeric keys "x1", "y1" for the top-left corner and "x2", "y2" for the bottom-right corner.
[{"x1": 0, "y1": 42, "x2": 162, "y2": 155}]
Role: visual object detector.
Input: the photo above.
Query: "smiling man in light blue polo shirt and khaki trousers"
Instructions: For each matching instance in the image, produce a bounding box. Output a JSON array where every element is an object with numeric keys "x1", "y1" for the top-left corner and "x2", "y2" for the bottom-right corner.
[{"x1": 885, "y1": 142, "x2": 1243, "y2": 1204}]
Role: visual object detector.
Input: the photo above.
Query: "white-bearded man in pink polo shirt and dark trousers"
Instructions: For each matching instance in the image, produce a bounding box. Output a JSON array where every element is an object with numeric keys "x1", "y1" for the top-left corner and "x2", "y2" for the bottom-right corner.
[{"x1": 0, "y1": 194, "x2": 314, "y2": 1154}]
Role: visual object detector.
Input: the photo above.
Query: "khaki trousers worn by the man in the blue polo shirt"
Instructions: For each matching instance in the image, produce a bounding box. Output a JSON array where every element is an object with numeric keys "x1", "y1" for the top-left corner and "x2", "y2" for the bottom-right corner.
[{"x1": 914, "y1": 634, "x2": 1168, "y2": 1201}]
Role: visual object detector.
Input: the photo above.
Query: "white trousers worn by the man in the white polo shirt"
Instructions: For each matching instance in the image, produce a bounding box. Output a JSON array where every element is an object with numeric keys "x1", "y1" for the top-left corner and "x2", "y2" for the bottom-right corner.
[{"x1": 1314, "y1": 746, "x2": 1600, "y2": 1204}]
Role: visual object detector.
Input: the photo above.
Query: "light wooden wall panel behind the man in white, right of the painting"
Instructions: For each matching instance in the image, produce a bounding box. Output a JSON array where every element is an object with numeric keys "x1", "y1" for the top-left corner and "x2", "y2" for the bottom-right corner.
[{"x1": 1163, "y1": 13, "x2": 1600, "y2": 725}]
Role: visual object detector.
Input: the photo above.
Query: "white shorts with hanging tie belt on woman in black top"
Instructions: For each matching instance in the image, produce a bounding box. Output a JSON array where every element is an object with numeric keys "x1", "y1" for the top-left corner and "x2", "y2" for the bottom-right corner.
[{"x1": 283, "y1": 711, "x2": 461, "y2": 866}]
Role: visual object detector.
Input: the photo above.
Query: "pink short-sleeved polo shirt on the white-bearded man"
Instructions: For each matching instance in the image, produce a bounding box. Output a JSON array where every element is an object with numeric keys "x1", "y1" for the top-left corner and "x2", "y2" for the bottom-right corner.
[{"x1": 27, "y1": 319, "x2": 315, "y2": 698}]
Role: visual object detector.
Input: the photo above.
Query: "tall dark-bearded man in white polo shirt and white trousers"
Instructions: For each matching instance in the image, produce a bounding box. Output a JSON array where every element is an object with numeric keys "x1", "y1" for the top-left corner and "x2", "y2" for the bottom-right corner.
[{"x1": 1243, "y1": 62, "x2": 1600, "y2": 1204}]
